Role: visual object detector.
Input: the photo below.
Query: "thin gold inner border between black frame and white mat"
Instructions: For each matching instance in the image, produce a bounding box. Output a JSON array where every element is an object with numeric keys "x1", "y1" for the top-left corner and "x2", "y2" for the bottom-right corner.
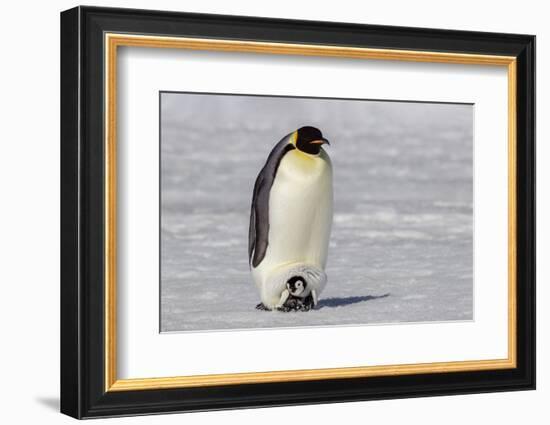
[{"x1": 104, "y1": 33, "x2": 517, "y2": 391}]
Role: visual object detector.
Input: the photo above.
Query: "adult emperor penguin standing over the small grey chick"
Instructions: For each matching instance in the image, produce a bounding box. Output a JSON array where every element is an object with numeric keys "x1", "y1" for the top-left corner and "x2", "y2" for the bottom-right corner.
[{"x1": 248, "y1": 126, "x2": 333, "y2": 310}]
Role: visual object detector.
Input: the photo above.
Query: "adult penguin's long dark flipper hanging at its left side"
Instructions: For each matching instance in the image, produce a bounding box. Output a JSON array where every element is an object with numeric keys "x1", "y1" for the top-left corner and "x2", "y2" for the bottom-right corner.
[{"x1": 248, "y1": 133, "x2": 295, "y2": 267}]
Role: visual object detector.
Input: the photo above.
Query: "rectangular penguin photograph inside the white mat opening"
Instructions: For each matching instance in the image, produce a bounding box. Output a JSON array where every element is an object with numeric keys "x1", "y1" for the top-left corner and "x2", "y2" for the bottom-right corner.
[{"x1": 159, "y1": 91, "x2": 474, "y2": 332}]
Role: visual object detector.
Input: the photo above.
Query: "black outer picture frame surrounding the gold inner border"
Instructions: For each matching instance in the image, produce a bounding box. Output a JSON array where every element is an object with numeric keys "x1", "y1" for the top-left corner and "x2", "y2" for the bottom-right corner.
[{"x1": 61, "y1": 7, "x2": 535, "y2": 418}]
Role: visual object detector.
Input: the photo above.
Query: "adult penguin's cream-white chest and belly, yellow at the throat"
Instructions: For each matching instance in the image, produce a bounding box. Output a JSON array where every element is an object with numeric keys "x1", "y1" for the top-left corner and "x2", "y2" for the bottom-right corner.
[{"x1": 264, "y1": 150, "x2": 332, "y2": 269}]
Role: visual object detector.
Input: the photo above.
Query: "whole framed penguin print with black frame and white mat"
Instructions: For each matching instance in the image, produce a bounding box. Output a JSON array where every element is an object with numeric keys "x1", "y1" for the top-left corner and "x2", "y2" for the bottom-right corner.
[{"x1": 61, "y1": 7, "x2": 535, "y2": 418}]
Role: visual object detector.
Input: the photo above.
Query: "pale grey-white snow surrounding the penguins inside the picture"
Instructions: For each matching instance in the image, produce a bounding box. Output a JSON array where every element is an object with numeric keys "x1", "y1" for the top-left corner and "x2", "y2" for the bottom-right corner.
[{"x1": 161, "y1": 94, "x2": 473, "y2": 331}]
